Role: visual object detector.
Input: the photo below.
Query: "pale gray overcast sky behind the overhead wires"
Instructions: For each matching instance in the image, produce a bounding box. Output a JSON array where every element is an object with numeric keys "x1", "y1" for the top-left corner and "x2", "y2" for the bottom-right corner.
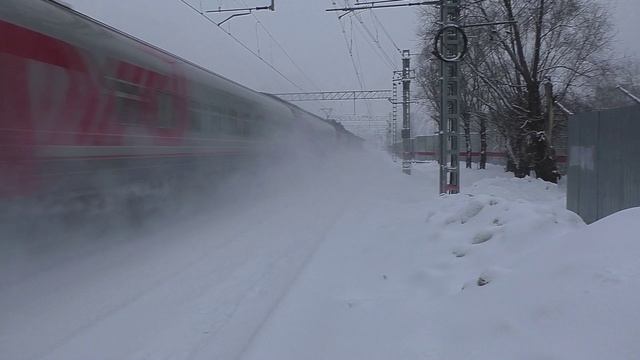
[{"x1": 66, "y1": 0, "x2": 640, "y2": 136}]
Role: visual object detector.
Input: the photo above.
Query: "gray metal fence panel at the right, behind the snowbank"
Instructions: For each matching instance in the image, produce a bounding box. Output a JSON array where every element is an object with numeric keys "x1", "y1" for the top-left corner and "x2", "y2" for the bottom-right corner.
[{"x1": 567, "y1": 106, "x2": 640, "y2": 223}]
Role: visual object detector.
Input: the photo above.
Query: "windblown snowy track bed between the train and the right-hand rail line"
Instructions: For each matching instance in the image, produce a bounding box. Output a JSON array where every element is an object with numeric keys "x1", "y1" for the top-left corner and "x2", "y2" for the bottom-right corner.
[{"x1": 0, "y1": 150, "x2": 400, "y2": 360}]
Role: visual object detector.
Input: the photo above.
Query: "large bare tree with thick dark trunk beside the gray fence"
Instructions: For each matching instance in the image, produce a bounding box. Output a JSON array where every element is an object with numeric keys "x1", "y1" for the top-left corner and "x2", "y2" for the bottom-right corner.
[{"x1": 424, "y1": 0, "x2": 611, "y2": 182}]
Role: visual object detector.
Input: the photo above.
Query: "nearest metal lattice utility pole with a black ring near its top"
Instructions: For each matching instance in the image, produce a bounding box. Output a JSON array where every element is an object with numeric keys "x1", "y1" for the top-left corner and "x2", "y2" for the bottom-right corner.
[{"x1": 436, "y1": 0, "x2": 466, "y2": 194}]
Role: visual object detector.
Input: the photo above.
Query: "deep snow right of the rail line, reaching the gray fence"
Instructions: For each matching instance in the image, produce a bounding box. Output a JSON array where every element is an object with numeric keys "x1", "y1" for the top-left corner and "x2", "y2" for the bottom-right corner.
[{"x1": 245, "y1": 164, "x2": 640, "y2": 360}]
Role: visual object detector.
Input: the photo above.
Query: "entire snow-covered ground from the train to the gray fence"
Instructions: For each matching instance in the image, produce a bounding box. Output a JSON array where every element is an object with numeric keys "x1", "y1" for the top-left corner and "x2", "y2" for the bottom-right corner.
[{"x1": 0, "y1": 153, "x2": 640, "y2": 360}]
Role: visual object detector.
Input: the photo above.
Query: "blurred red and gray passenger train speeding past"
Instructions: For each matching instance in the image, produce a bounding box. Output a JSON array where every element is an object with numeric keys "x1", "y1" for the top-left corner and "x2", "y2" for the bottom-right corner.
[{"x1": 0, "y1": 0, "x2": 356, "y2": 202}]
